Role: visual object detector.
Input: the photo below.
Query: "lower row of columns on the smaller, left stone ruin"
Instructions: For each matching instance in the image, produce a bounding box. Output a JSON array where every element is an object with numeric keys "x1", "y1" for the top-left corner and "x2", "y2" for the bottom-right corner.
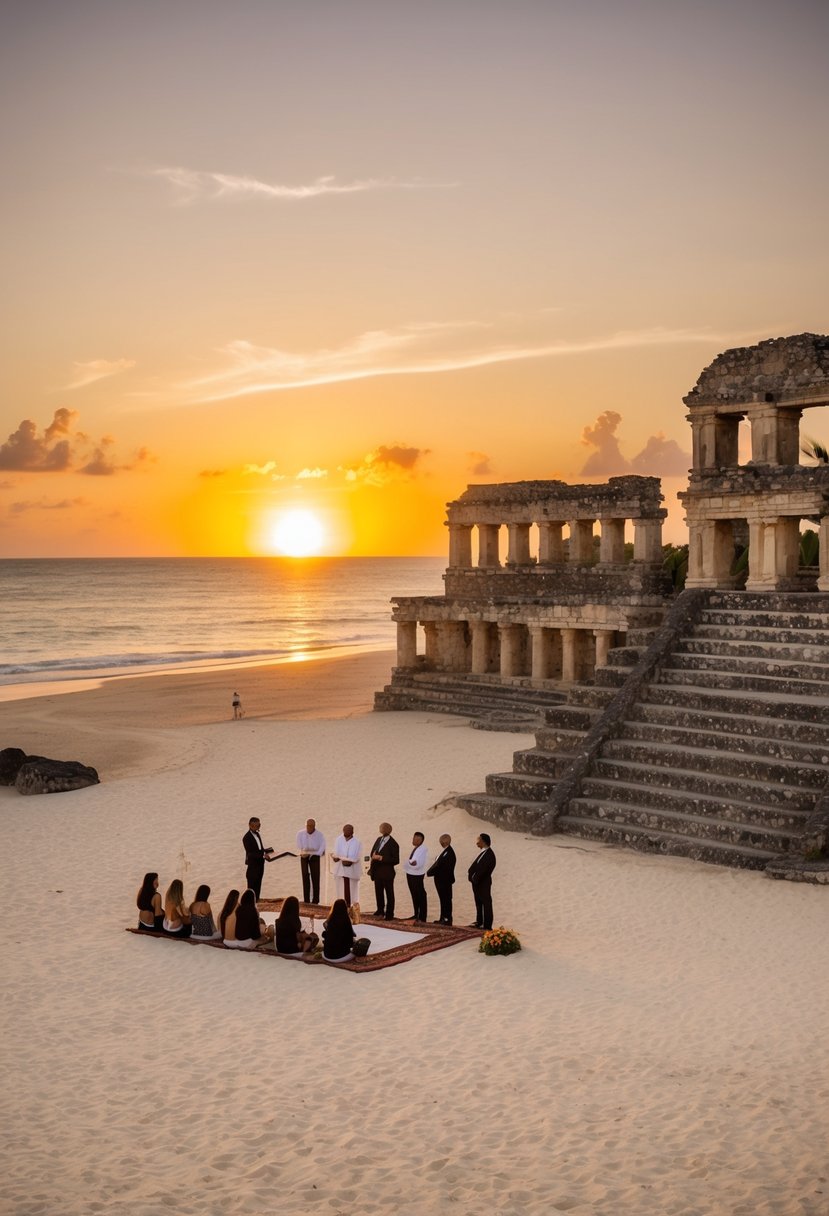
[{"x1": 397, "y1": 620, "x2": 616, "y2": 683}]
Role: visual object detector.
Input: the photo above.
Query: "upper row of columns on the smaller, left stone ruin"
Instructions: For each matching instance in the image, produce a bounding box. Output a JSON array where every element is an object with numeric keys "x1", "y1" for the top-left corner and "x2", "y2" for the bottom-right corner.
[{"x1": 447, "y1": 519, "x2": 662, "y2": 569}]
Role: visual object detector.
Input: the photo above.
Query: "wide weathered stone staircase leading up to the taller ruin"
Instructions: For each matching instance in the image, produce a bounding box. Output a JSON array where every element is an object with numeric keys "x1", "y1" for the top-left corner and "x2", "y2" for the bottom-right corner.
[{"x1": 452, "y1": 592, "x2": 829, "y2": 868}]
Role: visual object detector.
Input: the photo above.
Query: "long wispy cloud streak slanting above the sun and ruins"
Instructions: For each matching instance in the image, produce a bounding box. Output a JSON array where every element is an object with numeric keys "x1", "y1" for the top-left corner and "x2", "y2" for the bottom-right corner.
[{"x1": 154, "y1": 321, "x2": 728, "y2": 405}]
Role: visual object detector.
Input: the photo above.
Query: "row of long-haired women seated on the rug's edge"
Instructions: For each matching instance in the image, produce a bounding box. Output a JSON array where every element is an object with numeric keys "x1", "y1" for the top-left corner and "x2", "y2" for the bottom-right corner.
[{"x1": 135, "y1": 871, "x2": 364, "y2": 962}]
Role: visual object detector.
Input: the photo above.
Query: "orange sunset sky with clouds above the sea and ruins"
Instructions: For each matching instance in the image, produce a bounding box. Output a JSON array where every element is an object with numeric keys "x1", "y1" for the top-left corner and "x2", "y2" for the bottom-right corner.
[{"x1": 0, "y1": 0, "x2": 829, "y2": 557}]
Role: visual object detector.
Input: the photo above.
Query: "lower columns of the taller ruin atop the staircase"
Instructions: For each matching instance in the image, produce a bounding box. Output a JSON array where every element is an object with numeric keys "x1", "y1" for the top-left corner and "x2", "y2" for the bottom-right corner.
[{"x1": 686, "y1": 516, "x2": 829, "y2": 591}]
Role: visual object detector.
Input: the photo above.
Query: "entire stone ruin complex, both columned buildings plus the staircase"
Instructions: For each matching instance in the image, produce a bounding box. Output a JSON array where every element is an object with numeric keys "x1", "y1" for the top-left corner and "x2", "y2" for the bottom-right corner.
[{"x1": 377, "y1": 334, "x2": 829, "y2": 882}]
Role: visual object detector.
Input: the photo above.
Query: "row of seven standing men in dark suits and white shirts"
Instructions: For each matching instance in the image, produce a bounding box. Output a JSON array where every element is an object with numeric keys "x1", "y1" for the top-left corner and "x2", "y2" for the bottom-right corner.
[{"x1": 242, "y1": 816, "x2": 496, "y2": 929}]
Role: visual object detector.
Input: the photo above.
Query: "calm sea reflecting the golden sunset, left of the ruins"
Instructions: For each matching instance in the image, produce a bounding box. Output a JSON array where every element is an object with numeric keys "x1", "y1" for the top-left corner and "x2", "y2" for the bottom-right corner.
[{"x1": 0, "y1": 557, "x2": 446, "y2": 685}]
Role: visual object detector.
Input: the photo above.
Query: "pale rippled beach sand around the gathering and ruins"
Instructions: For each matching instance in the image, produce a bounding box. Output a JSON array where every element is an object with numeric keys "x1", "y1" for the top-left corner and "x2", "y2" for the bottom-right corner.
[{"x1": 0, "y1": 654, "x2": 829, "y2": 1216}]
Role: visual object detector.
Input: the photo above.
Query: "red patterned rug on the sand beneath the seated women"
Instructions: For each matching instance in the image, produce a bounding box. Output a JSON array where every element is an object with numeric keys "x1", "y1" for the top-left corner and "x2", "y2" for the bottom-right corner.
[{"x1": 126, "y1": 900, "x2": 481, "y2": 972}]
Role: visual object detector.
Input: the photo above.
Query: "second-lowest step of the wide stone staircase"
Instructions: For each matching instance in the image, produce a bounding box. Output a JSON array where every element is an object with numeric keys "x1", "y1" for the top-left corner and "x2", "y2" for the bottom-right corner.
[{"x1": 559, "y1": 798, "x2": 802, "y2": 854}]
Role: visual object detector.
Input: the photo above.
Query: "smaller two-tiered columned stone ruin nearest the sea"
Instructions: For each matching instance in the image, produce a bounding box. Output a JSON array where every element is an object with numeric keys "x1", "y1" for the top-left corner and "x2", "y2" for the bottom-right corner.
[{"x1": 376, "y1": 477, "x2": 671, "y2": 725}]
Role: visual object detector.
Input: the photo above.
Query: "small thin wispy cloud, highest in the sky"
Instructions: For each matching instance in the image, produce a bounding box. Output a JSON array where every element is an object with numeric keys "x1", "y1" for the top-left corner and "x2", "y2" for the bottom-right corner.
[{"x1": 148, "y1": 165, "x2": 456, "y2": 206}]
